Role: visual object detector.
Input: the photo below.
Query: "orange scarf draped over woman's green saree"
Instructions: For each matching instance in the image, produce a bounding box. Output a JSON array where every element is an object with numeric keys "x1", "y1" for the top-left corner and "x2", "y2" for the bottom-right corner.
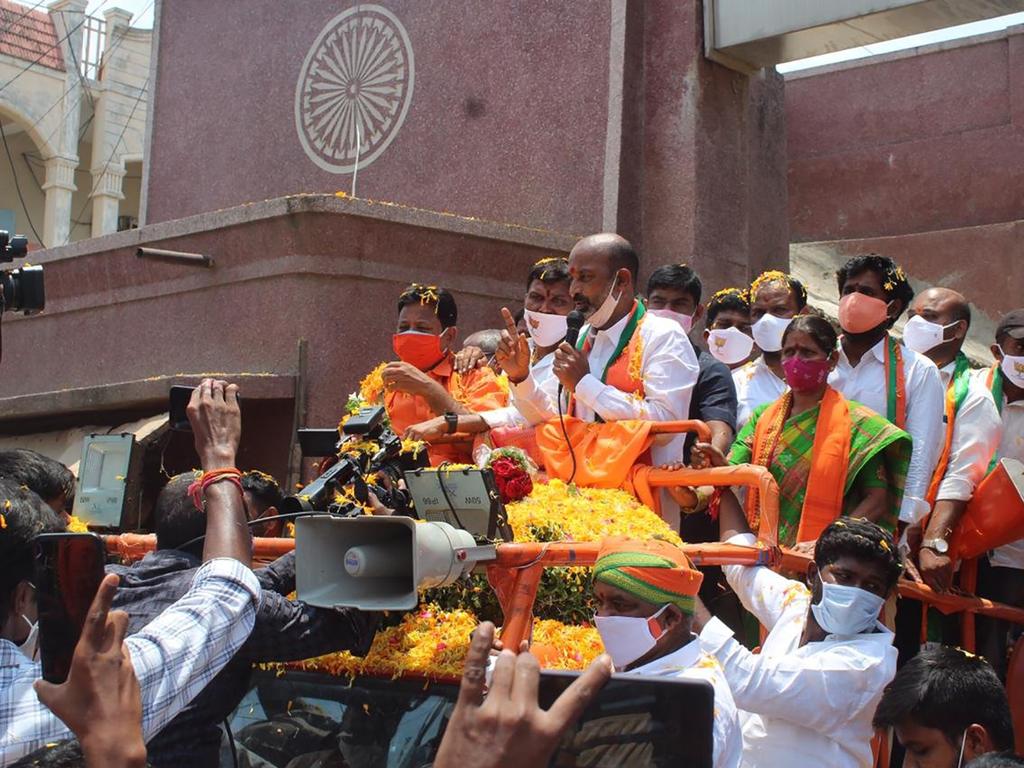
[{"x1": 746, "y1": 387, "x2": 853, "y2": 542}]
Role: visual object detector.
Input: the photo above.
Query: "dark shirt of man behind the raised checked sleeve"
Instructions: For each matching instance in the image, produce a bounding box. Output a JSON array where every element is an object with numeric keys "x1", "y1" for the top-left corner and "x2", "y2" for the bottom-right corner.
[{"x1": 108, "y1": 550, "x2": 378, "y2": 768}]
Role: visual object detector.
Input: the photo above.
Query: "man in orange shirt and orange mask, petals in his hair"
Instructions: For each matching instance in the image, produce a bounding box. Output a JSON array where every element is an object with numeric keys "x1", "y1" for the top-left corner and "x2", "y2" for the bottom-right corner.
[{"x1": 381, "y1": 284, "x2": 508, "y2": 465}]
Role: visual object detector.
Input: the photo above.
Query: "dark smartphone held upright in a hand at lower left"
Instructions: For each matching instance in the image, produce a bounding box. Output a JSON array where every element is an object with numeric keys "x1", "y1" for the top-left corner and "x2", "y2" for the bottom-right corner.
[{"x1": 34, "y1": 534, "x2": 106, "y2": 684}]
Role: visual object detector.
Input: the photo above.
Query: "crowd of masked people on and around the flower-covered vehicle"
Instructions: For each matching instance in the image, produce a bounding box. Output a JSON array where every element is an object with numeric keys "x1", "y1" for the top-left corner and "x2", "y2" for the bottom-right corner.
[{"x1": 0, "y1": 233, "x2": 1024, "y2": 768}]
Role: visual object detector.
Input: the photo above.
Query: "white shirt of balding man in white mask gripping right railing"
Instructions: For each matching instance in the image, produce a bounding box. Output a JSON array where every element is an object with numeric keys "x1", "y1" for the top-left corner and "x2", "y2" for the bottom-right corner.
[{"x1": 935, "y1": 361, "x2": 1002, "y2": 502}]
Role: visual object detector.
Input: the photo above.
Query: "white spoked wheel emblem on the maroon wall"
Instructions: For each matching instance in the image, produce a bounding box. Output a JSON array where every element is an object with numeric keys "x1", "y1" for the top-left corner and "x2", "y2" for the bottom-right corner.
[{"x1": 295, "y1": 5, "x2": 416, "y2": 173}]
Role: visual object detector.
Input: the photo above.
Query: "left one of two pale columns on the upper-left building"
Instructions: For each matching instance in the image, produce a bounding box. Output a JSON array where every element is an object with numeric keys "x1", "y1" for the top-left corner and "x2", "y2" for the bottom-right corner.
[{"x1": 43, "y1": 0, "x2": 88, "y2": 243}]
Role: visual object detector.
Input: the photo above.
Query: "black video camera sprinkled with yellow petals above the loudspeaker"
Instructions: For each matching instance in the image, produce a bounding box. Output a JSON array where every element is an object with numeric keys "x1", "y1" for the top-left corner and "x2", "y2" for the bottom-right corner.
[{"x1": 281, "y1": 406, "x2": 429, "y2": 517}]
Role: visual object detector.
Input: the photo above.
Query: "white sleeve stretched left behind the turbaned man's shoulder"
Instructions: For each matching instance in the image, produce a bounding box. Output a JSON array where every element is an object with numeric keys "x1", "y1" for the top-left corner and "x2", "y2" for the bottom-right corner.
[{"x1": 700, "y1": 618, "x2": 895, "y2": 733}]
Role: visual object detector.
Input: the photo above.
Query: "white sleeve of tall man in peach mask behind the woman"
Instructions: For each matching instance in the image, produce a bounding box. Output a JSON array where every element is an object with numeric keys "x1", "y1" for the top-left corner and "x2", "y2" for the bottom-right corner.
[{"x1": 899, "y1": 360, "x2": 945, "y2": 524}]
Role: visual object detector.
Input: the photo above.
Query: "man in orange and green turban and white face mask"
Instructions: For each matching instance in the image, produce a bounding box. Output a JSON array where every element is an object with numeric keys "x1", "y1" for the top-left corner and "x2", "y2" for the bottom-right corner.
[{"x1": 594, "y1": 537, "x2": 742, "y2": 768}]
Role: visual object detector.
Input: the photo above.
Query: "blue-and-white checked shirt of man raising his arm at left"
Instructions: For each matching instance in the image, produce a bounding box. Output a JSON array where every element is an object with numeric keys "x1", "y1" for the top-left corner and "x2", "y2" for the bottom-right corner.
[{"x1": 0, "y1": 558, "x2": 260, "y2": 765}]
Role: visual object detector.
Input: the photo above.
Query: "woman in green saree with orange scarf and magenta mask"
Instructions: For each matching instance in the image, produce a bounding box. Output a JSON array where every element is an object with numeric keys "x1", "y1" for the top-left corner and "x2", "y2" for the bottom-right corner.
[{"x1": 693, "y1": 315, "x2": 911, "y2": 551}]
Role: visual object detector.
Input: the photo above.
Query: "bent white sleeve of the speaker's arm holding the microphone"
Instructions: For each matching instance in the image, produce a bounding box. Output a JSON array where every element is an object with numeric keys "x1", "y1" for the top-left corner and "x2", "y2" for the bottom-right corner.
[{"x1": 575, "y1": 327, "x2": 699, "y2": 428}]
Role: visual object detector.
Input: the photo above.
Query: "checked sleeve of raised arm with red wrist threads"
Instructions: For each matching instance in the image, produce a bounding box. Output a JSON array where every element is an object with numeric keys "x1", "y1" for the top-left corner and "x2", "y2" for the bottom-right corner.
[{"x1": 125, "y1": 558, "x2": 260, "y2": 740}]
